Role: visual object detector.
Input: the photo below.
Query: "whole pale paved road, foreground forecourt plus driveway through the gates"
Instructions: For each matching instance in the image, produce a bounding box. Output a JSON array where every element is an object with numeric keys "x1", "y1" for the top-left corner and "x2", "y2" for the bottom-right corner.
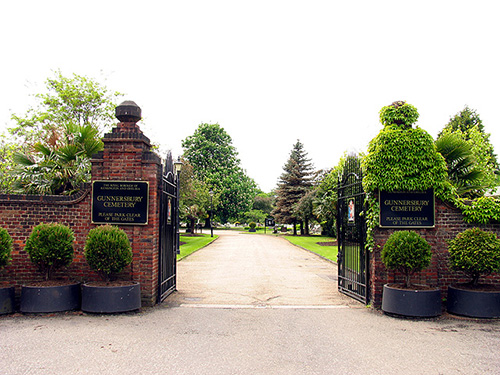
[{"x1": 0, "y1": 234, "x2": 500, "y2": 375}]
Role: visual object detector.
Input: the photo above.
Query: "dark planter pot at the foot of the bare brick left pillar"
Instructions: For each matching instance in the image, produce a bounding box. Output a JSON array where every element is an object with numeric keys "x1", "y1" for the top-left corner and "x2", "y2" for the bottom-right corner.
[{"x1": 82, "y1": 283, "x2": 141, "y2": 313}]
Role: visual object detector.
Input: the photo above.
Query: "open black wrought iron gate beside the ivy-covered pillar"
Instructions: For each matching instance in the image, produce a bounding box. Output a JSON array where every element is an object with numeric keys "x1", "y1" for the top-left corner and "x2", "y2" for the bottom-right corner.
[{"x1": 337, "y1": 156, "x2": 369, "y2": 304}]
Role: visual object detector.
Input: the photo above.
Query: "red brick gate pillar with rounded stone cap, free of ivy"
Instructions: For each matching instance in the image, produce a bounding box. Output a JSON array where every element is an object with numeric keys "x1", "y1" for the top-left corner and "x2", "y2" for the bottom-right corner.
[{"x1": 92, "y1": 101, "x2": 162, "y2": 306}]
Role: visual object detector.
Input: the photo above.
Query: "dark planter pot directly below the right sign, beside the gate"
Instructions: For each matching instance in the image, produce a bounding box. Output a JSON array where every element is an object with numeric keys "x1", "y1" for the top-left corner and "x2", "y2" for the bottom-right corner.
[{"x1": 382, "y1": 284, "x2": 442, "y2": 318}]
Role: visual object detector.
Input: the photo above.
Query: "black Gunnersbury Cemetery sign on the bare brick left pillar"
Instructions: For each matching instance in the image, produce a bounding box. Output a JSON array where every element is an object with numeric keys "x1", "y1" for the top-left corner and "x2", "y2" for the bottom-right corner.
[{"x1": 92, "y1": 180, "x2": 149, "y2": 225}]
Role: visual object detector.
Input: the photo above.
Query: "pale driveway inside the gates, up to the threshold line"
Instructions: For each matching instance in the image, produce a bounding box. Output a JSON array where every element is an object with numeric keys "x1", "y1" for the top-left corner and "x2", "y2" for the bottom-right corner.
[{"x1": 170, "y1": 231, "x2": 360, "y2": 306}]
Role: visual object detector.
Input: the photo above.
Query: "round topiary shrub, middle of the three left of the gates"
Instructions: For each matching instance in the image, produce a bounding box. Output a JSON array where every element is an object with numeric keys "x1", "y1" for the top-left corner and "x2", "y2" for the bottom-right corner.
[{"x1": 24, "y1": 223, "x2": 75, "y2": 280}]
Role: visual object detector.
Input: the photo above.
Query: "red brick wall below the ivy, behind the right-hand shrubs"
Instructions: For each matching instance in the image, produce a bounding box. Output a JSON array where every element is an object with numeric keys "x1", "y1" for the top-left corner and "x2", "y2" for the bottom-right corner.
[{"x1": 369, "y1": 199, "x2": 500, "y2": 307}]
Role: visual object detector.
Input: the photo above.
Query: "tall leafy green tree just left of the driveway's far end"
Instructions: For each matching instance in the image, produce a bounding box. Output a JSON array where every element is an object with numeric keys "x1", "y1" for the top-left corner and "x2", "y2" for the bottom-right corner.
[{"x1": 182, "y1": 124, "x2": 257, "y2": 222}]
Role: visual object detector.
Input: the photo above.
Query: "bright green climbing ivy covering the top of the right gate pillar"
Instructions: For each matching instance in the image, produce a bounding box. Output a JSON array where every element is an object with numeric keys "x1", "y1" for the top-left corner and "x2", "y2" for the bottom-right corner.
[{"x1": 363, "y1": 101, "x2": 451, "y2": 251}]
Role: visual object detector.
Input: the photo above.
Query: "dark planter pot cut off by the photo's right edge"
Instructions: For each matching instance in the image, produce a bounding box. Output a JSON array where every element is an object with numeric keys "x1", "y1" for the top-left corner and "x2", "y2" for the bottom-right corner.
[{"x1": 447, "y1": 285, "x2": 500, "y2": 318}]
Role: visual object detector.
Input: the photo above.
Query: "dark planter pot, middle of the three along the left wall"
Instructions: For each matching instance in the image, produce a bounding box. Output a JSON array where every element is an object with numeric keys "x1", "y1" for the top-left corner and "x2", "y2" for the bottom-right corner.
[{"x1": 21, "y1": 283, "x2": 81, "y2": 313}]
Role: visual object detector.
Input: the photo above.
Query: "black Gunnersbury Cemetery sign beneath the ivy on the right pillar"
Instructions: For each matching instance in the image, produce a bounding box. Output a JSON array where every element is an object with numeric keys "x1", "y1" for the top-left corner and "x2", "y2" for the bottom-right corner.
[{"x1": 379, "y1": 189, "x2": 434, "y2": 228}]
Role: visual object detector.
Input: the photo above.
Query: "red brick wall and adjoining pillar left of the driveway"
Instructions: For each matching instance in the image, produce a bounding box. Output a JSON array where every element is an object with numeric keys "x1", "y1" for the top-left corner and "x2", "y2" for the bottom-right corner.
[{"x1": 0, "y1": 122, "x2": 162, "y2": 306}]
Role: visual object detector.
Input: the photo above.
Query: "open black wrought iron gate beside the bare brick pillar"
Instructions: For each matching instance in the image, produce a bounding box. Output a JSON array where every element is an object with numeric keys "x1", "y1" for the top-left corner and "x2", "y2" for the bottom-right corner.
[{"x1": 158, "y1": 153, "x2": 179, "y2": 302}]
